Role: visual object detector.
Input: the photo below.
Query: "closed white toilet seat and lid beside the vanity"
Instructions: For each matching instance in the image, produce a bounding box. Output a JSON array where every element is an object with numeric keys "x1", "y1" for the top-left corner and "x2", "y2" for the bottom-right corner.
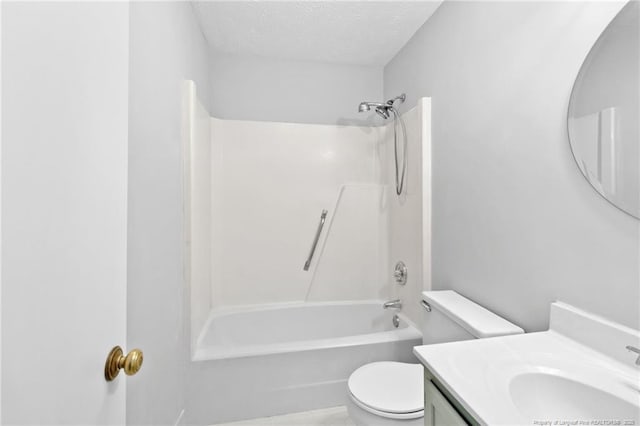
[{"x1": 348, "y1": 362, "x2": 424, "y2": 419}]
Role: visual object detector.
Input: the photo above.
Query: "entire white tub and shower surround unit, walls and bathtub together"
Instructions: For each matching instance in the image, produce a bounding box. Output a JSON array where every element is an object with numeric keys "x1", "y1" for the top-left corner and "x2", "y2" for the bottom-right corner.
[{"x1": 183, "y1": 82, "x2": 430, "y2": 424}]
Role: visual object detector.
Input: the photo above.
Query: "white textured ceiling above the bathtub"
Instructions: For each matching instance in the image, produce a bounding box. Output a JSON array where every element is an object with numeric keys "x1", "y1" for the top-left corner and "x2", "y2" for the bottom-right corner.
[{"x1": 193, "y1": 0, "x2": 442, "y2": 66}]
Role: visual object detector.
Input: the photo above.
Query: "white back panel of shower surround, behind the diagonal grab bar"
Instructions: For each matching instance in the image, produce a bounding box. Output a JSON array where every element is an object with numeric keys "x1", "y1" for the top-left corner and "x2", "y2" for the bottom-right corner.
[{"x1": 211, "y1": 118, "x2": 384, "y2": 308}]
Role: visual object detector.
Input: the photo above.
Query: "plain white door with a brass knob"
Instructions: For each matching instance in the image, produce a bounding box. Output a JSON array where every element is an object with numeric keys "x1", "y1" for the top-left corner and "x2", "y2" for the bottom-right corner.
[{"x1": 0, "y1": 2, "x2": 132, "y2": 424}]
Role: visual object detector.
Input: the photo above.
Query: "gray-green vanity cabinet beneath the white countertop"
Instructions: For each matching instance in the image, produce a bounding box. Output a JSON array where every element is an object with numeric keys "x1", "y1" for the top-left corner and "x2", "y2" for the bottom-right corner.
[{"x1": 424, "y1": 368, "x2": 478, "y2": 426}]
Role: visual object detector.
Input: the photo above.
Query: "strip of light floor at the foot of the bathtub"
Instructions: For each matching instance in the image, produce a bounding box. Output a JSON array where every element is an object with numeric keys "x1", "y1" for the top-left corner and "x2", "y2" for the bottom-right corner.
[{"x1": 217, "y1": 407, "x2": 355, "y2": 426}]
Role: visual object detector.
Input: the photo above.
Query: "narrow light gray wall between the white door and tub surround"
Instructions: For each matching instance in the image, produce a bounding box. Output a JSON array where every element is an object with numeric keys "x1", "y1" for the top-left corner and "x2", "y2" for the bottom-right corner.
[{"x1": 127, "y1": 2, "x2": 209, "y2": 425}]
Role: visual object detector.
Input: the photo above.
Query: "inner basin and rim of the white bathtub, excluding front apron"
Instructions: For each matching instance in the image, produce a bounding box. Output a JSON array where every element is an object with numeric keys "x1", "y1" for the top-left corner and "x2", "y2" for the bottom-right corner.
[{"x1": 193, "y1": 300, "x2": 421, "y2": 361}]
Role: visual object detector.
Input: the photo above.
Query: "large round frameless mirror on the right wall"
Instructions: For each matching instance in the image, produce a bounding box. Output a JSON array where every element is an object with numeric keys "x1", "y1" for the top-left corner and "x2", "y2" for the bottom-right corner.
[{"x1": 567, "y1": 0, "x2": 640, "y2": 218}]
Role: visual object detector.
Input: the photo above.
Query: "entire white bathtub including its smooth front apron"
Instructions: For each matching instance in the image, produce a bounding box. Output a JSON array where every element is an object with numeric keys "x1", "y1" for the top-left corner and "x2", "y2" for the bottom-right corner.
[{"x1": 185, "y1": 300, "x2": 422, "y2": 425}]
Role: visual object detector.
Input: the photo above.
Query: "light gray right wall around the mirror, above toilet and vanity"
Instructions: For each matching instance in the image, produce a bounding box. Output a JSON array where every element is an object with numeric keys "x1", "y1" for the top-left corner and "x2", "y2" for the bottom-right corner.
[{"x1": 384, "y1": 2, "x2": 640, "y2": 331}]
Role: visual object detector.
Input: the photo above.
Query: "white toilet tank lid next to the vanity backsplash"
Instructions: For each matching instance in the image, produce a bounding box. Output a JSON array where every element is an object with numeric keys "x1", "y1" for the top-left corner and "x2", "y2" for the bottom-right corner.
[{"x1": 422, "y1": 290, "x2": 524, "y2": 339}]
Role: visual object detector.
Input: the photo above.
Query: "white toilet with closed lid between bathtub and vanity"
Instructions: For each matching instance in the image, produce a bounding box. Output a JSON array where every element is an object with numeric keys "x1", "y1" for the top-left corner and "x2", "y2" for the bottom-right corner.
[{"x1": 347, "y1": 290, "x2": 524, "y2": 426}]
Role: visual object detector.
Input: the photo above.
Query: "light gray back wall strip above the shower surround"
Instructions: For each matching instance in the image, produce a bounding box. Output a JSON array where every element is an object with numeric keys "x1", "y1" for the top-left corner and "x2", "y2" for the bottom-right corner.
[{"x1": 210, "y1": 52, "x2": 382, "y2": 124}]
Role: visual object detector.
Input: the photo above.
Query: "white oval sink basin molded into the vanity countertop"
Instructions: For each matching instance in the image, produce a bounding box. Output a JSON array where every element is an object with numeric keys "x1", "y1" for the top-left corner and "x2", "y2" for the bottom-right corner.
[{"x1": 509, "y1": 372, "x2": 640, "y2": 424}]
